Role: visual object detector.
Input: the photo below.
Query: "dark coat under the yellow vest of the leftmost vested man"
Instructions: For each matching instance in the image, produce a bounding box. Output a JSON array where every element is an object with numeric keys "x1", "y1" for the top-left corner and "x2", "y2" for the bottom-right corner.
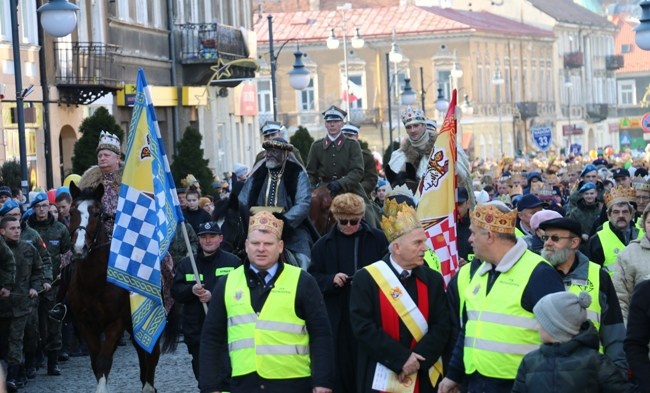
[{"x1": 199, "y1": 261, "x2": 334, "y2": 393}]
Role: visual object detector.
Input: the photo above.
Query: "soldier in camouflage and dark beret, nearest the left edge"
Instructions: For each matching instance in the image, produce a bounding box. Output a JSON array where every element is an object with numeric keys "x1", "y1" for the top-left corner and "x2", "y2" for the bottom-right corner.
[{"x1": 0, "y1": 216, "x2": 43, "y2": 391}]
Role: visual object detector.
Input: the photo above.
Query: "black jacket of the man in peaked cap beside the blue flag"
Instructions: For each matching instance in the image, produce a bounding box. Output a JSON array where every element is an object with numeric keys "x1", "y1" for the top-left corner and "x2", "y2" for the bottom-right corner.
[{"x1": 172, "y1": 248, "x2": 241, "y2": 344}]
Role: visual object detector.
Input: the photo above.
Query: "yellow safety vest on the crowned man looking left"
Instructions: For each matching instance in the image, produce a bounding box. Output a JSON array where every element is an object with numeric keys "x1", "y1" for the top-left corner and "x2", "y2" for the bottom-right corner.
[{"x1": 463, "y1": 250, "x2": 546, "y2": 379}]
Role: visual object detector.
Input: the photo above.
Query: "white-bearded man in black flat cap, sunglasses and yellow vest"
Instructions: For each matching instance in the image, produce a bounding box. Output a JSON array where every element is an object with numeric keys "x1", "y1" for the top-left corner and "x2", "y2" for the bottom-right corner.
[{"x1": 539, "y1": 218, "x2": 627, "y2": 373}]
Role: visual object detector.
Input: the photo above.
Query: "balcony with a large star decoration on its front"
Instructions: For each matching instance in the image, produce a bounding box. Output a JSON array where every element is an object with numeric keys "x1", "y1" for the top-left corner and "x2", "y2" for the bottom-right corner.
[{"x1": 177, "y1": 23, "x2": 257, "y2": 87}]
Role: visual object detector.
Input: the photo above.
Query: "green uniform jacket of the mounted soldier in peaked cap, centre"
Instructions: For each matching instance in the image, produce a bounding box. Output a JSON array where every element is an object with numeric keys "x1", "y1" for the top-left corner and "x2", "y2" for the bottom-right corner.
[{"x1": 307, "y1": 133, "x2": 364, "y2": 197}]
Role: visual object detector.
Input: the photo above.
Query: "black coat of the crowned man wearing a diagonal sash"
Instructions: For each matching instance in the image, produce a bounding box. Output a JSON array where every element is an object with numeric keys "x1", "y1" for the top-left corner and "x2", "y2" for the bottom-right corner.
[{"x1": 350, "y1": 256, "x2": 451, "y2": 393}]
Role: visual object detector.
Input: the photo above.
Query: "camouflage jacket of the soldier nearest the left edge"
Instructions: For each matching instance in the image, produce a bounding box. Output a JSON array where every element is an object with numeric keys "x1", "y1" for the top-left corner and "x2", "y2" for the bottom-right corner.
[{"x1": 1, "y1": 240, "x2": 43, "y2": 317}]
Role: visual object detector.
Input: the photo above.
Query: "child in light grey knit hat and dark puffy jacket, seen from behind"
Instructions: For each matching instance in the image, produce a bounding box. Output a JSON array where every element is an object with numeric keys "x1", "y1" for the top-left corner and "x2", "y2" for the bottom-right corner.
[{"x1": 512, "y1": 292, "x2": 638, "y2": 393}]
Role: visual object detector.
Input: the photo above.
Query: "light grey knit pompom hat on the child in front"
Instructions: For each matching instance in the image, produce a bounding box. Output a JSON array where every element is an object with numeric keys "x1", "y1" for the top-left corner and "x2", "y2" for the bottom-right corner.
[{"x1": 533, "y1": 292, "x2": 591, "y2": 343}]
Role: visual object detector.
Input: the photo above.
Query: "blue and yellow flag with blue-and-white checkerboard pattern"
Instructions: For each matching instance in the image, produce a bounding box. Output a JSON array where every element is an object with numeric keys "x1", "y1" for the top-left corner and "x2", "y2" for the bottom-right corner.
[{"x1": 107, "y1": 68, "x2": 183, "y2": 353}]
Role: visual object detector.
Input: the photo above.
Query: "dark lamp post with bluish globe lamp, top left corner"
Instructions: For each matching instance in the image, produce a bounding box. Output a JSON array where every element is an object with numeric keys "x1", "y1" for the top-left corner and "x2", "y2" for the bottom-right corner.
[{"x1": 9, "y1": 0, "x2": 79, "y2": 202}]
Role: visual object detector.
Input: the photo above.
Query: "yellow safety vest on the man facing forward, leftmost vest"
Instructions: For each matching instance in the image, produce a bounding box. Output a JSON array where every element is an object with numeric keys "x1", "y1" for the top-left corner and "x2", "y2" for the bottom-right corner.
[{"x1": 225, "y1": 264, "x2": 311, "y2": 379}]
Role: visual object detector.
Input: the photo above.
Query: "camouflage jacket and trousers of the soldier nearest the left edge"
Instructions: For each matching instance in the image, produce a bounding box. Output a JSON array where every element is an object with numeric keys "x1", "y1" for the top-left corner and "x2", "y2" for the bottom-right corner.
[{"x1": 0, "y1": 240, "x2": 43, "y2": 366}]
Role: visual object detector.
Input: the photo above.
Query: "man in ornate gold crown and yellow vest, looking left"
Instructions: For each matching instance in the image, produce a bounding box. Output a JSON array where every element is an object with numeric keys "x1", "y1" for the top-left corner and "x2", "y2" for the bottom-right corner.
[{"x1": 438, "y1": 201, "x2": 564, "y2": 393}]
